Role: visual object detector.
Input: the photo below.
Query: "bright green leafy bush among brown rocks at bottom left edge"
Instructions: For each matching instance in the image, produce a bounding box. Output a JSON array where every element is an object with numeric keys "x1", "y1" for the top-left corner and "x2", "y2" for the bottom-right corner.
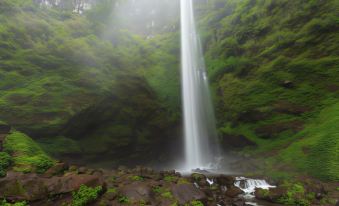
[{"x1": 71, "y1": 185, "x2": 102, "y2": 206}]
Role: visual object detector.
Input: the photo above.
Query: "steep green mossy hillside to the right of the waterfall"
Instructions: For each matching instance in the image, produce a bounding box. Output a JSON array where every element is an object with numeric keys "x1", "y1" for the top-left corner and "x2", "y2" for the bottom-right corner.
[{"x1": 198, "y1": 0, "x2": 339, "y2": 180}]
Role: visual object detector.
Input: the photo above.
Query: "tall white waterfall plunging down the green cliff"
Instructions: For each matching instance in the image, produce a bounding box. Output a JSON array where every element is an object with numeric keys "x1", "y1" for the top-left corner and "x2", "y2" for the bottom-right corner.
[{"x1": 180, "y1": 0, "x2": 218, "y2": 170}]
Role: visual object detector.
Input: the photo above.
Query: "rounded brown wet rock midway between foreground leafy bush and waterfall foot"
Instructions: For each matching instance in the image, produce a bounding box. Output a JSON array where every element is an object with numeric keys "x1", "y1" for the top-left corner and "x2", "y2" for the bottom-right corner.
[{"x1": 120, "y1": 182, "x2": 152, "y2": 202}]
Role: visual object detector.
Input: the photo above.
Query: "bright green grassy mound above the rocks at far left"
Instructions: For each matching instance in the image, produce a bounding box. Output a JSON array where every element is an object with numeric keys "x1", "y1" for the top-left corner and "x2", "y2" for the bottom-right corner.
[{"x1": 4, "y1": 131, "x2": 54, "y2": 173}]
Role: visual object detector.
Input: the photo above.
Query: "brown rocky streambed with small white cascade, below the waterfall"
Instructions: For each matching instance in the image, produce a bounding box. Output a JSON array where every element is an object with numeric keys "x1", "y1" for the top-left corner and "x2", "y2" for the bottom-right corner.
[{"x1": 0, "y1": 163, "x2": 338, "y2": 206}]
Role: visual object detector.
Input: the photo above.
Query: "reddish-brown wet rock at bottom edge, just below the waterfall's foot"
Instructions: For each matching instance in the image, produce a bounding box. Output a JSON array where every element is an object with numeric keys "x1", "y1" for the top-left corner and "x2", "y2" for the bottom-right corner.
[{"x1": 171, "y1": 184, "x2": 207, "y2": 204}]
